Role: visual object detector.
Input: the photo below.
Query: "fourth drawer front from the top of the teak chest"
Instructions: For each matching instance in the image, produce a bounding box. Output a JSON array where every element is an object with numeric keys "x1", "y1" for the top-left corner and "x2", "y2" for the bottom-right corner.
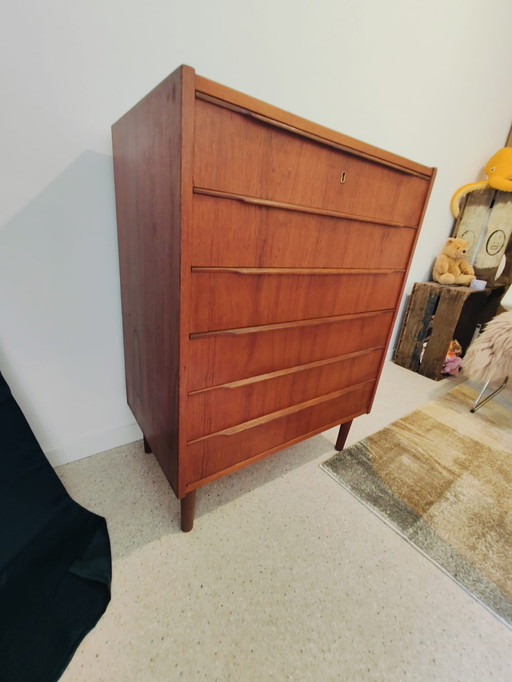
[{"x1": 188, "y1": 311, "x2": 393, "y2": 391}]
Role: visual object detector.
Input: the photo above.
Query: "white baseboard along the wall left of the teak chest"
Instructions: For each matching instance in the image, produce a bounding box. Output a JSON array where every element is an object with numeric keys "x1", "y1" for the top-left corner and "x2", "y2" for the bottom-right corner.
[{"x1": 43, "y1": 423, "x2": 142, "y2": 467}]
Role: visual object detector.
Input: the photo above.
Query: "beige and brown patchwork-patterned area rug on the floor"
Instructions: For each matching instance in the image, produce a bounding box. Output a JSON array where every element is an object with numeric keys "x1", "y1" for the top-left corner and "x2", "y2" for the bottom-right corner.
[{"x1": 322, "y1": 384, "x2": 512, "y2": 627}]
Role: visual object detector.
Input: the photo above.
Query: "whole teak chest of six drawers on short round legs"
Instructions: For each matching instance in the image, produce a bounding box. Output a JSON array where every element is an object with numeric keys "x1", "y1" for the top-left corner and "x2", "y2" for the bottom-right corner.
[{"x1": 112, "y1": 66, "x2": 434, "y2": 530}]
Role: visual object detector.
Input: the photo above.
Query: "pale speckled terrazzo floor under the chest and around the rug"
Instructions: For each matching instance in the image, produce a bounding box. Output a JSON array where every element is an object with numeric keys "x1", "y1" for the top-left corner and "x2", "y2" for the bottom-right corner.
[{"x1": 57, "y1": 362, "x2": 512, "y2": 682}]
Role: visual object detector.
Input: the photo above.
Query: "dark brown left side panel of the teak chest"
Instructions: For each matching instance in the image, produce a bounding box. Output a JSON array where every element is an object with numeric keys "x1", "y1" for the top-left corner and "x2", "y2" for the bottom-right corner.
[{"x1": 112, "y1": 69, "x2": 187, "y2": 491}]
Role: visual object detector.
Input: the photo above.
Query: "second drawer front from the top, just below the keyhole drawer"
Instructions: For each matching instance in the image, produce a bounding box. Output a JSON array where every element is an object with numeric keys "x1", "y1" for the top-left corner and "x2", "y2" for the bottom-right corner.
[{"x1": 191, "y1": 194, "x2": 416, "y2": 268}]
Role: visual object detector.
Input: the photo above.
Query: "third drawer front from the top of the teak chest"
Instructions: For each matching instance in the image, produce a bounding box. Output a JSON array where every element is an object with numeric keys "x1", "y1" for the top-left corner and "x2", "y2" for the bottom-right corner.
[{"x1": 190, "y1": 268, "x2": 404, "y2": 333}]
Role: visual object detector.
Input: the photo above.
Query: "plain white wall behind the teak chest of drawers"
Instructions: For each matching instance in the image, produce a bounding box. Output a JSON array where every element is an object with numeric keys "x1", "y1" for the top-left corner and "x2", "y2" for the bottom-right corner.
[{"x1": 0, "y1": 0, "x2": 512, "y2": 464}]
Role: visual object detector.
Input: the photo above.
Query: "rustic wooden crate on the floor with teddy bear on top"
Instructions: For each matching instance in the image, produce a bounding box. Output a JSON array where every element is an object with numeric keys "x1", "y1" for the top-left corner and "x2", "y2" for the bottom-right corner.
[{"x1": 394, "y1": 282, "x2": 489, "y2": 380}]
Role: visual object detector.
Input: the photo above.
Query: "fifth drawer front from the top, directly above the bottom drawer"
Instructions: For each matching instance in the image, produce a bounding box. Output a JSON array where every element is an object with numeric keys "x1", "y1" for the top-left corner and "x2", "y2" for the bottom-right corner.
[{"x1": 187, "y1": 348, "x2": 383, "y2": 440}]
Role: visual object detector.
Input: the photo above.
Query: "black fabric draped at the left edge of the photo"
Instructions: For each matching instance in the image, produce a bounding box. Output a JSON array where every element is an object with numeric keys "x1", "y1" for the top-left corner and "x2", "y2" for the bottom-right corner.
[{"x1": 0, "y1": 374, "x2": 112, "y2": 682}]
